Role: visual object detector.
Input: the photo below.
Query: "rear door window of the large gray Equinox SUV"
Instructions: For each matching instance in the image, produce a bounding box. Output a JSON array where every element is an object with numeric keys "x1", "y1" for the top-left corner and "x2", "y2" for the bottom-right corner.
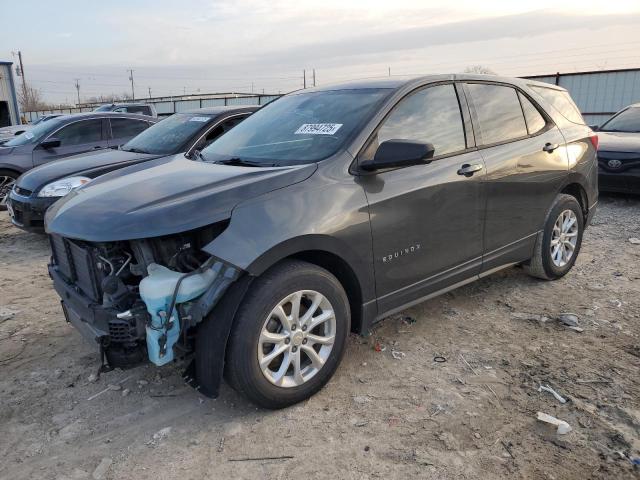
[{"x1": 467, "y1": 83, "x2": 527, "y2": 145}]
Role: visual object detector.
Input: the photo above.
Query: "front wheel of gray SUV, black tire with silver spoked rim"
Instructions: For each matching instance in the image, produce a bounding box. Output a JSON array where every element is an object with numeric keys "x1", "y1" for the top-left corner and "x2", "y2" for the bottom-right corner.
[{"x1": 225, "y1": 261, "x2": 351, "y2": 408}]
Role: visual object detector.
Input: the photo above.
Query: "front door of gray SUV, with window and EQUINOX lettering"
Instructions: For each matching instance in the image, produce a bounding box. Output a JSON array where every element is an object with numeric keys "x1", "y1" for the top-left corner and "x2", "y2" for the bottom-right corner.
[{"x1": 359, "y1": 83, "x2": 484, "y2": 315}]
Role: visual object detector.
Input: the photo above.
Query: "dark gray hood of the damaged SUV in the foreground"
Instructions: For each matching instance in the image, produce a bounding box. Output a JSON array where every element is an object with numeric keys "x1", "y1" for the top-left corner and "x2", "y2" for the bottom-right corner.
[{"x1": 45, "y1": 155, "x2": 317, "y2": 242}]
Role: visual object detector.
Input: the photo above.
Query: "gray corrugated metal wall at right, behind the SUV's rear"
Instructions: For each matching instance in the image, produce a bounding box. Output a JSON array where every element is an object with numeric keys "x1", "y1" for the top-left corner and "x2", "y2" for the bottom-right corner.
[{"x1": 525, "y1": 68, "x2": 640, "y2": 125}]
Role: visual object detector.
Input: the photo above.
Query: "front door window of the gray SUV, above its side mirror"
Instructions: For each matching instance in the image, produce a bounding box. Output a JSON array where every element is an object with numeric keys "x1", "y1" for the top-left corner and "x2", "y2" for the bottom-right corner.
[{"x1": 362, "y1": 81, "x2": 466, "y2": 160}]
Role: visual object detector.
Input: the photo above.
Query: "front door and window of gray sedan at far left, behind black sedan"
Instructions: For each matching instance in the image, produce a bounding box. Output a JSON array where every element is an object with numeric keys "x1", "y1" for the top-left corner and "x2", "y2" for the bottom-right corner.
[{"x1": 33, "y1": 118, "x2": 107, "y2": 166}]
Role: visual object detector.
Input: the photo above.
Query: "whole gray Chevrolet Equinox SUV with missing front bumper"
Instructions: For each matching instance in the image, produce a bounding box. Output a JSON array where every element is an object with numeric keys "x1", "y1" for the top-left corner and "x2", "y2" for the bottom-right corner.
[{"x1": 45, "y1": 75, "x2": 598, "y2": 408}]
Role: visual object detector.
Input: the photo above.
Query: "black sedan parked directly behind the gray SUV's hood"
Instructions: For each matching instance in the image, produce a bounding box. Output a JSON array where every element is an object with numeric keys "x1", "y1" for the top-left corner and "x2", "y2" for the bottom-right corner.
[{"x1": 7, "y1": 106, "x2": 258, "y2": 232}]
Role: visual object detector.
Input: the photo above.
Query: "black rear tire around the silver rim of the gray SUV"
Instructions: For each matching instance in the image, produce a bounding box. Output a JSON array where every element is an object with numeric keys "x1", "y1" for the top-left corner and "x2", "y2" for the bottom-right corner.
[{"x1": 524, "y1": 194, "x2": 584, "y2": 280}]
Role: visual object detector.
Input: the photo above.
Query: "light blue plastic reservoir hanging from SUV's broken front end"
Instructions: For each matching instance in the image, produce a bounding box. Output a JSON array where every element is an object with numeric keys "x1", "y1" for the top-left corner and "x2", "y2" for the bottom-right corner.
[{"x1": 140, "y1": 263, "x2": 221, "y2": 366}]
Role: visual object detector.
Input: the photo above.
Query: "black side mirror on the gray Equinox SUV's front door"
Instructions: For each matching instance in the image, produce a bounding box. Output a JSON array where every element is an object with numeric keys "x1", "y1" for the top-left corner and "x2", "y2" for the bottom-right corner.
[{"x1": 360, "y1": 140, "x2": 435, "y2": 172}]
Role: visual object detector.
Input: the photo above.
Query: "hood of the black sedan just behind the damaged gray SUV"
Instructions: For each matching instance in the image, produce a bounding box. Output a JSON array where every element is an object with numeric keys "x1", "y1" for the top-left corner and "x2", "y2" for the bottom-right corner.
[{"x1": 17, "y1": 149, "x2": 161, "y2": 192}]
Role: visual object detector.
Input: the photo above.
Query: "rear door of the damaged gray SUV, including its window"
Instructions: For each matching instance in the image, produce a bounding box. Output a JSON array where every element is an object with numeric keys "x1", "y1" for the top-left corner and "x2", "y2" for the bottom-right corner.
[{"x1": 465, "y1": 83, "x2": 568, "y2": 272}]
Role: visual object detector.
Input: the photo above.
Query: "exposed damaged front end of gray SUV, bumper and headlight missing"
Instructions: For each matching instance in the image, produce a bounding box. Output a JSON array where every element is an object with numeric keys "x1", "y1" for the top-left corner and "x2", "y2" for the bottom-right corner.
[{"x1": 49, "y1": 222, "x2": 241, "y2": 382}]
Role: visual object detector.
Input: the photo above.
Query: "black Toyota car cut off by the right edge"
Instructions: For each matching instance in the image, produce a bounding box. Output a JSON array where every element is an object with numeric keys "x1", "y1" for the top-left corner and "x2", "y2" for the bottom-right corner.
[{"x1": 597, "y1": 103, "x2": 640, "y2": 193}]
